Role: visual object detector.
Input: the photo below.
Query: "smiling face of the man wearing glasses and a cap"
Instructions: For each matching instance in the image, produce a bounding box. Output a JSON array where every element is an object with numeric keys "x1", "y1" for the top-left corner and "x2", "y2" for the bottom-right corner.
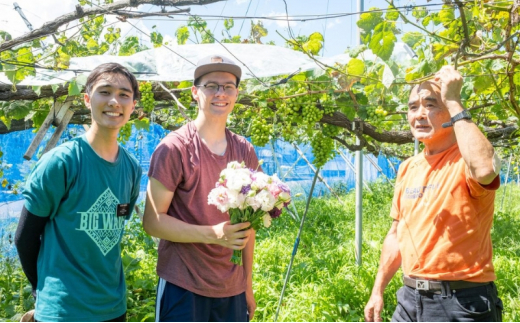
[{"x1": 191, "y1": 72, "x2": 238, "y2": 118}]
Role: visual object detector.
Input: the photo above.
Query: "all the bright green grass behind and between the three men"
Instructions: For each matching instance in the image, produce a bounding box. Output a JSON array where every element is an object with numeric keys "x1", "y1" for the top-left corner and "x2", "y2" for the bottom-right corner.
[{"x1": 0, "y1": 183, "x2": 520, "y2": 322}]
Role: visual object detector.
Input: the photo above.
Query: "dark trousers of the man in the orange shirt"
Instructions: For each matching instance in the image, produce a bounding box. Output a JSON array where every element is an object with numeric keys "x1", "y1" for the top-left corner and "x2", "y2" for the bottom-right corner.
[{"x1": 392, "y1": 283, "x2": 503, "y2": 322}]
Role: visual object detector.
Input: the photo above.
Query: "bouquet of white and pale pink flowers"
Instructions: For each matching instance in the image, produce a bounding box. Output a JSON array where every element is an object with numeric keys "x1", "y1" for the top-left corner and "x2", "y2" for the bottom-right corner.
[{"x1": 208, "y1": 161, "x2": 291, "y2": 265}]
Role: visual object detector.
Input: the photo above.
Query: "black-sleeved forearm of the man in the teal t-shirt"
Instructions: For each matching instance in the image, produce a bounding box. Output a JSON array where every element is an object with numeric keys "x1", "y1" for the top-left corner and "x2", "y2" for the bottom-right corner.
[{"x1": 14, "y1": 207, "x2": 48, "y2": 290}]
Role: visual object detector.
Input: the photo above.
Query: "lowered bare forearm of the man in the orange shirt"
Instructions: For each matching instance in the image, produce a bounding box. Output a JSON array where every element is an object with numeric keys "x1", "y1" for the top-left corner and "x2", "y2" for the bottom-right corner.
[{"x1": 372, "y1": 221, "x2": 401, "y2": 295}]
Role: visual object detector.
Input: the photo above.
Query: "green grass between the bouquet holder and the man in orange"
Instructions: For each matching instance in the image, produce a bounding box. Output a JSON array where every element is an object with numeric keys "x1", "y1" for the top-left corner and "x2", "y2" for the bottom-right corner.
[{"x1": 253, "y1": 185, "x2": 399, "y2": 321}]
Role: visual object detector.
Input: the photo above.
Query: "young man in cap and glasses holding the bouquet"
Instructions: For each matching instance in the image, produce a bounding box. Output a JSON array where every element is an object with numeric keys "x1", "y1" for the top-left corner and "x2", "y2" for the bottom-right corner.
[{"x1": 143, "y1": 55, "x2": 258, "y2": 322}]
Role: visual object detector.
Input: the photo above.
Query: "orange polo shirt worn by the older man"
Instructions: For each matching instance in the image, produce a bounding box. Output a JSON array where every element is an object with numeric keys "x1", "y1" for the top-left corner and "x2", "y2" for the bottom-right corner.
[{"x1": 390, "y1": 144, "x2": 500, "y2": 282}]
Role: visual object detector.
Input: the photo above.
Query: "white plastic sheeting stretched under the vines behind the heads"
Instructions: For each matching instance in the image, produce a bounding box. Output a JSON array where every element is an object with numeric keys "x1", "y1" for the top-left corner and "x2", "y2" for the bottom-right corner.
[{"x1": 0, "y1": 43, "x2": 413, "y2": 86}]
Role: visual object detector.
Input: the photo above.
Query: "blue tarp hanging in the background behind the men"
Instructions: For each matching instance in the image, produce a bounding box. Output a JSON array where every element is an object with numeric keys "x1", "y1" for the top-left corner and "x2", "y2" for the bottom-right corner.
[{"x1": 0, "y1": 124, "x2": 399, "y2": 256}]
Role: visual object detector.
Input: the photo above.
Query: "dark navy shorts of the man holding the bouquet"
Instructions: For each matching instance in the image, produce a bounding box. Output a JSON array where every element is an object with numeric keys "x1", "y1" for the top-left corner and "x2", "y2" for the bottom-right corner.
[{"x1": 155, "y1": 279, "x2": 249, "y2": 322}]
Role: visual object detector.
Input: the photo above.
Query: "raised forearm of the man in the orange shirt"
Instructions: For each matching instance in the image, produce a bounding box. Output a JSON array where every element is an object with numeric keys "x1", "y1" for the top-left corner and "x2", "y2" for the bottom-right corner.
[{"x1": 447, "y1": 101, "x2": 500, "y2": 185}]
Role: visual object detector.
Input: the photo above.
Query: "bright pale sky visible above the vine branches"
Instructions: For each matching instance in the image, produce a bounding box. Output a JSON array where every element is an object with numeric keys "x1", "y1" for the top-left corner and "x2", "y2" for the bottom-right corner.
[{"x1": 0, "y1": 0, "x2": 434, "y2": 57}]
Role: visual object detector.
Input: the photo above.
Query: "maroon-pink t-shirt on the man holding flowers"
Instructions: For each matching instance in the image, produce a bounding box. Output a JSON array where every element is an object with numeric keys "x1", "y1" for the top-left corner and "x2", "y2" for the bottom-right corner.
[{"x1": 148, "y1": 122, "x2": 258, "y2": 297}]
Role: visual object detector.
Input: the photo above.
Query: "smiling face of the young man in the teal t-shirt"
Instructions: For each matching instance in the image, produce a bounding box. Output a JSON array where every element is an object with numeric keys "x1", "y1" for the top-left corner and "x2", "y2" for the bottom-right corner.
[{"x1": 84, "y1": 73, "x2": 136, "y2": 131}]
